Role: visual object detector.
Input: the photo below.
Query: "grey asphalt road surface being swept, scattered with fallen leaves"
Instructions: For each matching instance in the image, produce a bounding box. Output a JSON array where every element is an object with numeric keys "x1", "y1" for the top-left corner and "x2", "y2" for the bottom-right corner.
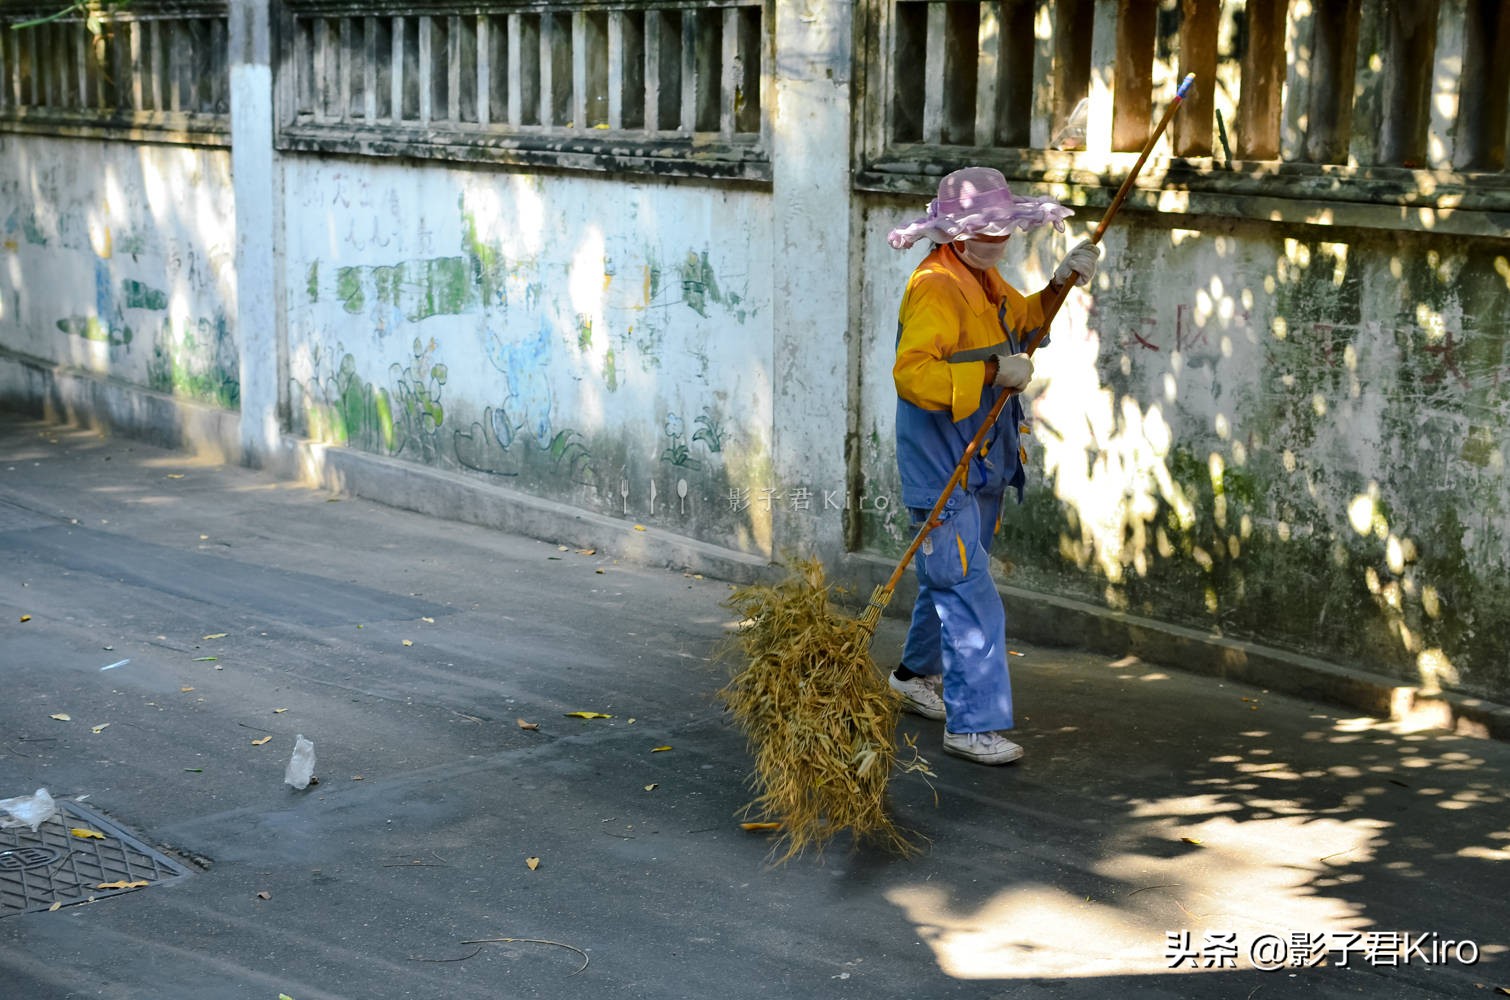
[{"x1": 0, "y1": 415, "x2": 1510, "y2": 1000}]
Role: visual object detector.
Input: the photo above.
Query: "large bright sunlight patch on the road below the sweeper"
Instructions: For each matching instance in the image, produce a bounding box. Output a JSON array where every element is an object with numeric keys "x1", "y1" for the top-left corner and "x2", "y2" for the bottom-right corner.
[{"x1": 886, "y1": 796, "x2": 1385, "y2": 979}]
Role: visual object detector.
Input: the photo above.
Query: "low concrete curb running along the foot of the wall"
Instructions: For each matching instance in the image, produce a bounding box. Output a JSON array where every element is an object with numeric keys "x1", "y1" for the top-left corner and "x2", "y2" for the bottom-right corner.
[{"x1": 0, "y1": 361, "x2": 1510, "y2": 740}]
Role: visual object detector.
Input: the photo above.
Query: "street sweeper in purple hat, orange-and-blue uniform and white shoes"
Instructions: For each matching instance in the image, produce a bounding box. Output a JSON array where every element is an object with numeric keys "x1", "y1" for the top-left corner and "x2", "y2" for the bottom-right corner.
[{"x1": 888, "y1": 166, "x2": 1101, "y2": 764}]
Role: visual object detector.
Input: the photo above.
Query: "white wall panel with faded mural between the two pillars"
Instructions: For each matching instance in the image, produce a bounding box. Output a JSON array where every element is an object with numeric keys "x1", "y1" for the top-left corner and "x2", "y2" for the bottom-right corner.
[{"x1": 287, "y1": 163, "x2": 770, "y2": 551}]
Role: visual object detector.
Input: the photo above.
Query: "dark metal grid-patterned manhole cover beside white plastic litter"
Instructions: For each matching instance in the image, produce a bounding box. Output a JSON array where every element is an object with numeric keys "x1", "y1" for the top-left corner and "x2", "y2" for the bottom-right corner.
[{"x1": 0, "y1": 802, "x2": 193, "y2": 917}]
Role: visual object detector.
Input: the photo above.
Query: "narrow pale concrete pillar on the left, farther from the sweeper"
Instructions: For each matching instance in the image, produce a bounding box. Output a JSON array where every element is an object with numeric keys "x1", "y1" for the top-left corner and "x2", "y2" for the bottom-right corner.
[{"x1": 230, "y1": 0, "x2": 285, "y2": 465}]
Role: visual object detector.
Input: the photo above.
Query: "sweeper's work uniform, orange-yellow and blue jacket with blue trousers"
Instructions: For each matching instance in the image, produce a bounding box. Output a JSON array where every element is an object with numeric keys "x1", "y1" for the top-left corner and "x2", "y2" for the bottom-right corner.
[{"x1": 892, "y1": 246, "x2": 1043, "y2": 733}]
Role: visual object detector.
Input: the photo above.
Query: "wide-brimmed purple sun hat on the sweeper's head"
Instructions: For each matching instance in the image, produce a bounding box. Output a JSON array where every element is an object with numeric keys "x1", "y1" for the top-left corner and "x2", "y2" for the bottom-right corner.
[{"x1": 886, "y1": 166, "x2": 1075, "y2": 249}]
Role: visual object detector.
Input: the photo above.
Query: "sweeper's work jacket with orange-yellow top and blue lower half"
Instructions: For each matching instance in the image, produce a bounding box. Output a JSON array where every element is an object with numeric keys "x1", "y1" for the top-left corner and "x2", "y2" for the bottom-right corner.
[{"x1": 891, "y1": 246, "x2": 1046, "y2": 509}]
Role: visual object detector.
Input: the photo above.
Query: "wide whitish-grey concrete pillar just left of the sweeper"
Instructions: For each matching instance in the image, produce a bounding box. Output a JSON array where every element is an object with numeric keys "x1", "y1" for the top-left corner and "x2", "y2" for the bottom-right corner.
[{"x1": 770, "y1": 0, "x2": 859, "y2": 565}]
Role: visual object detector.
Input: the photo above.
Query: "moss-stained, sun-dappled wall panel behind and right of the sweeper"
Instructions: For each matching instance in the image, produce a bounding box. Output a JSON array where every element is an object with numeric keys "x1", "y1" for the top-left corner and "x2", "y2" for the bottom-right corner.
[{"x1": 864, "y1": 206, "x2": 1510, "y2": 692}]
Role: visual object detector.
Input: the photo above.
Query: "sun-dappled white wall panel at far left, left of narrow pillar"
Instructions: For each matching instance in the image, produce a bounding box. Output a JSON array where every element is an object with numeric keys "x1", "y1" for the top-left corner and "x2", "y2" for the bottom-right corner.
[{"x1": 0, "y1": 136, "x2": 240, "y2": 409}]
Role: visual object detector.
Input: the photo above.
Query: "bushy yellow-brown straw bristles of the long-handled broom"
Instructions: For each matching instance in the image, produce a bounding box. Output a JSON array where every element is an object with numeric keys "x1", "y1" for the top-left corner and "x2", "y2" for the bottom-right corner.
[{"x1": 719, "y1": 559, "x2": 929, "y2": 864}]
